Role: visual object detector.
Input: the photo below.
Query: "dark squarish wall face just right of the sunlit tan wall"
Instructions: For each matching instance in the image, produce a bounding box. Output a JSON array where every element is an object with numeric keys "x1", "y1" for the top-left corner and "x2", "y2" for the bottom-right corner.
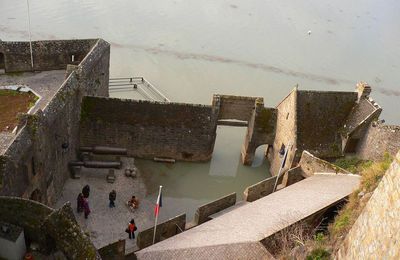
[{"x1": 296, "y1": 91, "x2": 357, "y2": 158}]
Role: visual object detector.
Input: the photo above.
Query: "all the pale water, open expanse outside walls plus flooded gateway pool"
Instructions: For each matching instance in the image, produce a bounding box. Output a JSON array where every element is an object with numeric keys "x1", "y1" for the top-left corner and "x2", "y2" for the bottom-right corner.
[{"x1": 0, "y1": 0, "x2": 400, "y2": 220}]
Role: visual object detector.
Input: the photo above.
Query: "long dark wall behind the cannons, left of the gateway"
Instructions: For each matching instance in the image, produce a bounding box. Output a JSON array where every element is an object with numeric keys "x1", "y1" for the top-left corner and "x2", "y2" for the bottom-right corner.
[{"x1": 81, "y1": 97, "x2": 217, "y2": 161}]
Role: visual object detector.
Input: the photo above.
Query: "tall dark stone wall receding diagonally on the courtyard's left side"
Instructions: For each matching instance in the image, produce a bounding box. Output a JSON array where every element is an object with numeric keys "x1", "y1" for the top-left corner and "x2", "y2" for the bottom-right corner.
[{"x1": 0, "y1": 40, "x2": 110, "y2": 204}]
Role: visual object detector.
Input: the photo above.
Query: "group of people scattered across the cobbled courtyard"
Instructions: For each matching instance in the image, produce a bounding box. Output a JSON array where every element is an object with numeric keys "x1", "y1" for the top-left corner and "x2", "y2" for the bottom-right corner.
[{"x1": 77, "y1": 185, "x2": 139, "y2": 239}]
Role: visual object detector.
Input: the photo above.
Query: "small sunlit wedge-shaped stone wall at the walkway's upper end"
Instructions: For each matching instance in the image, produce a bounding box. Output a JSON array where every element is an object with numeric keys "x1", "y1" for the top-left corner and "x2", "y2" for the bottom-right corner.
[{"x1": 299, "y1": 151, "x2": 351, "y2": 176}]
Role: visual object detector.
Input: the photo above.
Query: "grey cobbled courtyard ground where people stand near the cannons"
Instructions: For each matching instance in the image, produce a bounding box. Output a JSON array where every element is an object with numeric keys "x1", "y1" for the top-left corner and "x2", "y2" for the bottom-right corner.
[{"x1": 55, "y1": 158, "x2": 159, "y2": 252}]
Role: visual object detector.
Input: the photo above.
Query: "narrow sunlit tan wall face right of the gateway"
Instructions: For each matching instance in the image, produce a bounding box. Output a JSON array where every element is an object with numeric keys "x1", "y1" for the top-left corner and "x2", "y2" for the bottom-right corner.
[{"x1": 268, "y1": 89, "x2": 297, "y2": 175}]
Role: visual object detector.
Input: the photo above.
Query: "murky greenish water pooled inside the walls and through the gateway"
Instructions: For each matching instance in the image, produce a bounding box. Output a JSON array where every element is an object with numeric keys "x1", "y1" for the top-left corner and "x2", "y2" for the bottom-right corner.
[{"x1": 136, "y1": 126, "x2": 270, "y2": 220}]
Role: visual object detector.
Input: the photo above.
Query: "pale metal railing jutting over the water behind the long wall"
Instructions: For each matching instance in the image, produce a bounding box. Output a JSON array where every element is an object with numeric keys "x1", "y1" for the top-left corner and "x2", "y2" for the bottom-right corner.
[{"x1": 109, "y1": 77, "x2": 171, "y2": 102}]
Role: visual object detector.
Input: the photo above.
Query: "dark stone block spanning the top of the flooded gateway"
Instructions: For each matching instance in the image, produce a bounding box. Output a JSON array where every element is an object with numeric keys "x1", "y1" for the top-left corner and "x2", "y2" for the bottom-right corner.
[{"x1": 212, "y1": 95, "x2": 262, "y2": 121}]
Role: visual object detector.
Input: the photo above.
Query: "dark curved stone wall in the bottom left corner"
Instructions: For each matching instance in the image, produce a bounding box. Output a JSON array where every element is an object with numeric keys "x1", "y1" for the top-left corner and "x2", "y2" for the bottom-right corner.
[{"x1": 0, "y1": 196, "x2": 99, "y2": 259}]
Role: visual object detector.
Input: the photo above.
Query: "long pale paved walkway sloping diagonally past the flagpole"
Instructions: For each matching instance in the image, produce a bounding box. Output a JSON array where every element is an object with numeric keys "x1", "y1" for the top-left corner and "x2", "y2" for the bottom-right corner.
[{"x1": 137, "y1": 174, "x2": 359, "y2": 259}]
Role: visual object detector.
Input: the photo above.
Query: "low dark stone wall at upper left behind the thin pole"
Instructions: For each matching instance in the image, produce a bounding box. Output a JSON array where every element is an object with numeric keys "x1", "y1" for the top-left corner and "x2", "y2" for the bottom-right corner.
[{"x1": 0, "y1": 39, "x2": 97, "y2": 72}]
